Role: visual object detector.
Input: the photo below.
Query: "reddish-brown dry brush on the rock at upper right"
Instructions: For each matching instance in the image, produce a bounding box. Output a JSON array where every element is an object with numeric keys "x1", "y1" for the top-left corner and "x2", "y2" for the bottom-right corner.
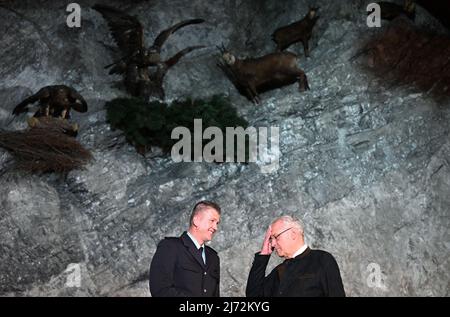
[{"x1": 353, "y1": 18, "x2": 450, "y2": 103}]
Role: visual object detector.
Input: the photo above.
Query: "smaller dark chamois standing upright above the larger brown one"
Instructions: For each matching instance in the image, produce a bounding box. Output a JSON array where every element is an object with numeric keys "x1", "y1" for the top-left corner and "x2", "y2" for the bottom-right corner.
[{"x1": 272, "y1": 8, "x2": 319, "y2": 57}]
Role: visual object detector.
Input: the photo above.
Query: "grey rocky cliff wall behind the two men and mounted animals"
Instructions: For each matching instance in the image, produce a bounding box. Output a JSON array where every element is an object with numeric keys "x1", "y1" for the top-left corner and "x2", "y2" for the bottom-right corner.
[{"x1": 0, "y1": 0, "x2": 450, "y2": 296}]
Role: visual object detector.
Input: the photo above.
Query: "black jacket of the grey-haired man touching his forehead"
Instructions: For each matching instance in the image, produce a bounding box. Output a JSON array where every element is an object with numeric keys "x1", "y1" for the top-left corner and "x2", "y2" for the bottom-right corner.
[{"x1": 246, "y1": 248, "x2": 345, "y2": 297}]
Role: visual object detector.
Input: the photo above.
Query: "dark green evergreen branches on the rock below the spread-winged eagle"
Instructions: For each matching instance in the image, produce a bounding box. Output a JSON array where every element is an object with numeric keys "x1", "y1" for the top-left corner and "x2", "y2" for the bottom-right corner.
[{"x1": 105, "y1": 95, "x2": 248, "y2": 158}]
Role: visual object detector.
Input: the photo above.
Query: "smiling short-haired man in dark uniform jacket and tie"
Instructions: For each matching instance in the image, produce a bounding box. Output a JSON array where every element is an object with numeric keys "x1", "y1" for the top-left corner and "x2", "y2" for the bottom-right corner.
[{"x1": 149, "y1": 200, "x2": 220, "y2": 297}]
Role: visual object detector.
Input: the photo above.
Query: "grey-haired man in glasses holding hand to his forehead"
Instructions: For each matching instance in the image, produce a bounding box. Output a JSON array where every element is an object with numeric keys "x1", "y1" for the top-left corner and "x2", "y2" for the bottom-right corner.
[{"x1": 246, "y1": 216, "x2": 345, "y2": 297}]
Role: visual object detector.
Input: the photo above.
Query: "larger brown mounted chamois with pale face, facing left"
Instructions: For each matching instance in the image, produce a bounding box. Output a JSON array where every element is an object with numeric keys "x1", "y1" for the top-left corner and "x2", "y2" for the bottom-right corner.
[{"x1": 218, "y1": 45, "x2": 309, "y2": 104}]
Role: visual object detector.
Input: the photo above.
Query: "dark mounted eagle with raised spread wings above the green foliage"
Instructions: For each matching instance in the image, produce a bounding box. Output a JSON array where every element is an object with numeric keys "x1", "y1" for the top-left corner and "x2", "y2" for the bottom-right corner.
[{"x1": 92, "y1": 4, "x2": 205, "y2": 99}]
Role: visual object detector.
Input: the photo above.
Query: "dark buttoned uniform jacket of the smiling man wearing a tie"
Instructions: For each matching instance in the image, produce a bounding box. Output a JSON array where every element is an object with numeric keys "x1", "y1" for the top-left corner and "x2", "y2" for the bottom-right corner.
[{"x1": 150, "y1": 232, "x2": 220, "y2": 297}]
